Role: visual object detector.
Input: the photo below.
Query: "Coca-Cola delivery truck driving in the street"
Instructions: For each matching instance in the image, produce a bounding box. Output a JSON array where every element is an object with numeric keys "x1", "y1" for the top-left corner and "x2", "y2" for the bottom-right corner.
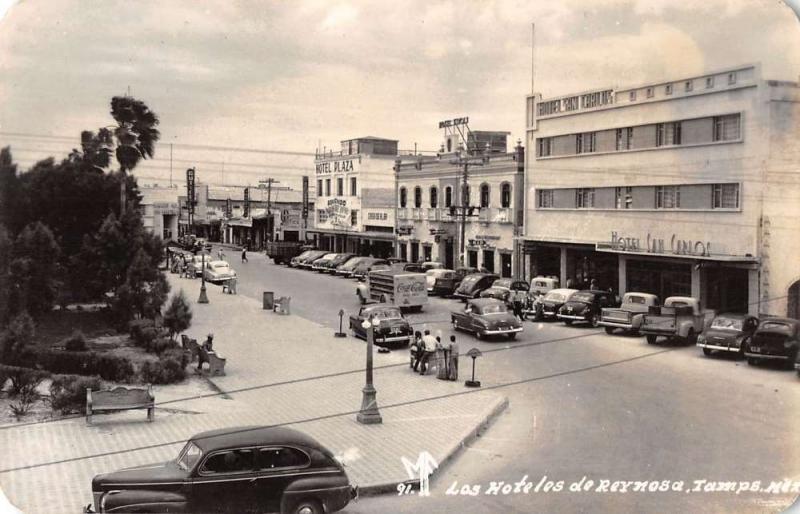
[{"x1": 356, "y1": 269, "x2": 428, "y2": 311}]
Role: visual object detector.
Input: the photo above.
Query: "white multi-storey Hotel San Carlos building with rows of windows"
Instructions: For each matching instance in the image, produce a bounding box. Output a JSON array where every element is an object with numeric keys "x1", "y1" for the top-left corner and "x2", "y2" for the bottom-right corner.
[{"x1": 525, "y1": 65, "x2": 800, "y2": 315}]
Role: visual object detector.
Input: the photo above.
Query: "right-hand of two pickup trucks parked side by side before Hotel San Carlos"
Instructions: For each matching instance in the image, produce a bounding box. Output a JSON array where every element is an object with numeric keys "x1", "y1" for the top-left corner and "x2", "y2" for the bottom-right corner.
[{"x1": 639, "y1": 296, "x2": 706, "y2": 344}]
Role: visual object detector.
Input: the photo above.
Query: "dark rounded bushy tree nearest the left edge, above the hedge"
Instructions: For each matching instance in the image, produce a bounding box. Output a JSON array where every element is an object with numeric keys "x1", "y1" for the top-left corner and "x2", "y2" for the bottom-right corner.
[{"x1": 10, "y1": 221, "x2": 61, "y2": 316}]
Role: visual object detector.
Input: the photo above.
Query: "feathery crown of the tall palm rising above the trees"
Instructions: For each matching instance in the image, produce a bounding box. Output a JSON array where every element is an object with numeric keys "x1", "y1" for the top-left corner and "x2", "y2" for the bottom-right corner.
[{"x1": 111, "y1": 96, "x2": 161, "y2": 173}]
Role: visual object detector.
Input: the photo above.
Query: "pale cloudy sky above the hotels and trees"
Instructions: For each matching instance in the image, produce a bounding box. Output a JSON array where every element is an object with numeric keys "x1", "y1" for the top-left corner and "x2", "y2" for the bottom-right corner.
[{"x1": 0, "y1": 0, "x2": 800, "y2": 187}]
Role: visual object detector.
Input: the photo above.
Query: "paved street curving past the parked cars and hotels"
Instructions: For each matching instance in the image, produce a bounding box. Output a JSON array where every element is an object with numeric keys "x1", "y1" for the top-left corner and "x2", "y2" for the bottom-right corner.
[{"x1": 223, "y1": 246, "x2": 800, "y2": 513}]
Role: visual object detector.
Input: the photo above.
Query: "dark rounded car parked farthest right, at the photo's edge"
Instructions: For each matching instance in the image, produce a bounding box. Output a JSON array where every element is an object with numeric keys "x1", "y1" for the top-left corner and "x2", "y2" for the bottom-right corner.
[{"x1": 744, "y1": 318, "x2": 800, "y2": 369}]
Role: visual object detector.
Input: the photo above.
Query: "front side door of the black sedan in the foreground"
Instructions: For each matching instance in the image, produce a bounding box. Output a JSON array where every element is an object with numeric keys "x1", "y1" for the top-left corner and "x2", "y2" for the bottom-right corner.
[{"x1": 191, "y1": 448, "x2": 259, "y2": 513}]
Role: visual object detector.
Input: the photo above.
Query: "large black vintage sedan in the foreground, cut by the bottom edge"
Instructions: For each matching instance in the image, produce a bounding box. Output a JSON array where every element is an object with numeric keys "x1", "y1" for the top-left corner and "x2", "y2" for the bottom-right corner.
[{"x1": 84, "y1": 427, "x2": 358, "y2": 514}]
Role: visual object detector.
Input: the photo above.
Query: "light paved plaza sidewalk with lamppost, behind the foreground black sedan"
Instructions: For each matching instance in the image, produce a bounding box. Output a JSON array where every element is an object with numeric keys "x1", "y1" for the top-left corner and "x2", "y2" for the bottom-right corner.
[{"x1": 0, "y1": 274, "x2": 507, "y2": 513}]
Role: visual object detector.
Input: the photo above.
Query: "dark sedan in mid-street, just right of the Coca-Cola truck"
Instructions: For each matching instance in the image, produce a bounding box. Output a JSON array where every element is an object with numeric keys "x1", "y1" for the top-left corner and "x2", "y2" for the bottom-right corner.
[{"x1": 450, "y1": 298, "x2": 522, "y2": 339}]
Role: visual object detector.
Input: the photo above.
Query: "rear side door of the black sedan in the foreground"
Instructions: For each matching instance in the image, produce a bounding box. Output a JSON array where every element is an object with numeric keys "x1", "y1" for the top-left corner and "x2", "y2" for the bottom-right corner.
[{"x1": 255, "y1": 446, "x2": 311, "y2": 512}]
